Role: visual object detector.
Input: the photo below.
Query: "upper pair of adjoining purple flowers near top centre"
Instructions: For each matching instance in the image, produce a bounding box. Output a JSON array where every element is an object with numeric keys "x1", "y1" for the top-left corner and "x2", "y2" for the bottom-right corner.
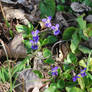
[{"x1": 42, "y1": 16, "x2": 60, "y2": 35}]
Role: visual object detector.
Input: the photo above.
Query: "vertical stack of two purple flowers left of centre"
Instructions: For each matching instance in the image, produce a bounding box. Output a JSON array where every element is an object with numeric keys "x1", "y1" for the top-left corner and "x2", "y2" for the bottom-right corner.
[{"x1": 30, "y1": 30, "x2": 39, "y2": 50}]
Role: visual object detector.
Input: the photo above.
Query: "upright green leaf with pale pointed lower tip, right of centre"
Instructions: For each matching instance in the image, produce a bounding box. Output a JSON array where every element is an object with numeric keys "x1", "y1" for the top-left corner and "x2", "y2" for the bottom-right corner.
[{"x1": 70, "y1": 32, "x2": 81, "y2": 53}]
